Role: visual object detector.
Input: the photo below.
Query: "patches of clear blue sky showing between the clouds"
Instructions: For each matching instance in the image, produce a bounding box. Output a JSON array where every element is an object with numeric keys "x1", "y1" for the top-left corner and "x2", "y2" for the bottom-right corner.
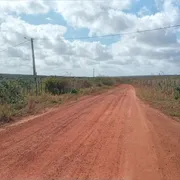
[{"x1": 20, "y1": 0, "x2": 157, "y2": 45}]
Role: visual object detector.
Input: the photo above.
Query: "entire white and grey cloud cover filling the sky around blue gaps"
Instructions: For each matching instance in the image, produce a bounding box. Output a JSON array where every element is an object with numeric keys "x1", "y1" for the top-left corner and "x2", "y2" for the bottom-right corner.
[{"x1": 0, "y1": 0, "x2": 180, "y2": 76}]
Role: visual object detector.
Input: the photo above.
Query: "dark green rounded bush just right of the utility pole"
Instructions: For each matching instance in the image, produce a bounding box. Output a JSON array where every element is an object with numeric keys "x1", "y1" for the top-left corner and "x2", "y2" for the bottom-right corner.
[{"x1": 45, "y1": 78, "x2": 71, "y2": 95}]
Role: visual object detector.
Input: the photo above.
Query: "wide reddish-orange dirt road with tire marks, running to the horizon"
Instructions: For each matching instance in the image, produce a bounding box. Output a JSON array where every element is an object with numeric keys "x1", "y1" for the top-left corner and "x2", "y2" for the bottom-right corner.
[{"x1": 0, "y1": 85, "x2": 180, "y2": 180}]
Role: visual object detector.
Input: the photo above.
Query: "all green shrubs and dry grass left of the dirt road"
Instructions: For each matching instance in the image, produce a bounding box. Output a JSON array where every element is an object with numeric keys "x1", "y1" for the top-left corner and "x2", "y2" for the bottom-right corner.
[{"x1": 0, "y1": 77, "x2": 117, "y2": 123}]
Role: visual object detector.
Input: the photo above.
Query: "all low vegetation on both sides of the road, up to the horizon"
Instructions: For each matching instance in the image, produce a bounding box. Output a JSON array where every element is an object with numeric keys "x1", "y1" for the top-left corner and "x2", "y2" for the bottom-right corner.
[{"x1": 0, "y1": 76, "x2": 180, "y2": 123}]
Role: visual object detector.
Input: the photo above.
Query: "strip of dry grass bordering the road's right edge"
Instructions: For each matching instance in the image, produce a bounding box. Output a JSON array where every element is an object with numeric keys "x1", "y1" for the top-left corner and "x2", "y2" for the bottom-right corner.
[{"x1": 136, "y1": 86, "x2": 180, "y2": 121}]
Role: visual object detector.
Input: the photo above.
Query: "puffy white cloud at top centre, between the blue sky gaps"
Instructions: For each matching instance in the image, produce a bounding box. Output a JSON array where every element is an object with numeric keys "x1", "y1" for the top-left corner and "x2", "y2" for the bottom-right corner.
[{"x1": 56, "y1": 0, "x2": 136, "y2": 35}]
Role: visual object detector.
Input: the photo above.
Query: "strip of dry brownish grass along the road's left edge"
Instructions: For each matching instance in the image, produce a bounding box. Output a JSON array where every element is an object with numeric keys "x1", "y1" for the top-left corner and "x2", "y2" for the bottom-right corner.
[{"x1": 0, "y1": 86, "x2": 111, "y2": 124}]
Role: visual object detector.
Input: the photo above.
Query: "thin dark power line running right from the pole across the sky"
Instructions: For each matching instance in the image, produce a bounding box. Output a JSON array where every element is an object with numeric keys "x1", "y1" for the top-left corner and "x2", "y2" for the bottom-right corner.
[{"x1": 37, "y1": 24, "x2": 180, "y2": 40}]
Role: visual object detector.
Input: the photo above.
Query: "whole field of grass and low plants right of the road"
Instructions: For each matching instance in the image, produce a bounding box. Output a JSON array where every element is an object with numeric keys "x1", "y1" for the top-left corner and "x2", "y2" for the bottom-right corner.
[{"x1": 132, "y1": 76, "x2": 180, "y2": 121}]
